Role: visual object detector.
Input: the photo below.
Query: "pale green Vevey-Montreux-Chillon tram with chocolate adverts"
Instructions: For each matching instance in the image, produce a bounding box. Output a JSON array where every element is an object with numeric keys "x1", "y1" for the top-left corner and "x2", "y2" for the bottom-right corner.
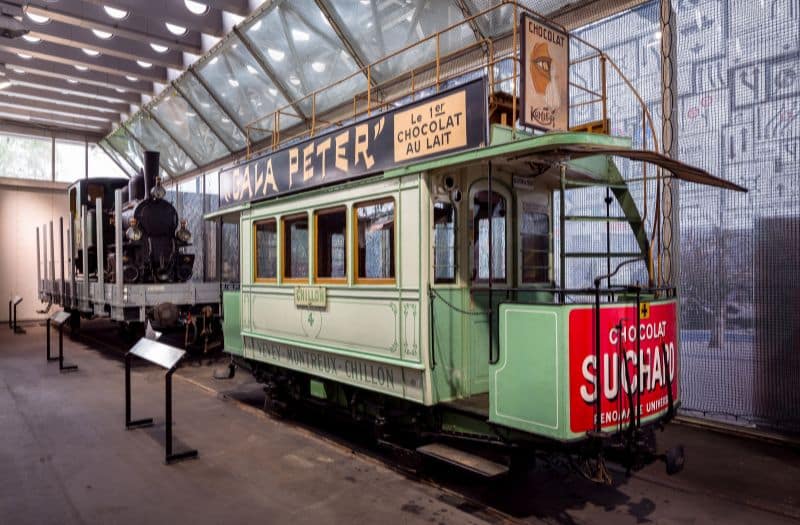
[{"x1": 207, "y1": 21, "x2": 743, "y2": 475}]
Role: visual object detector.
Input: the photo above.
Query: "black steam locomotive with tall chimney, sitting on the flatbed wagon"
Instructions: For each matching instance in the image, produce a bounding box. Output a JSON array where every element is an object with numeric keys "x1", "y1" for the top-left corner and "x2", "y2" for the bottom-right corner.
[{"x1": 70, "y1": 151, "x2": 194, "y2": 283}]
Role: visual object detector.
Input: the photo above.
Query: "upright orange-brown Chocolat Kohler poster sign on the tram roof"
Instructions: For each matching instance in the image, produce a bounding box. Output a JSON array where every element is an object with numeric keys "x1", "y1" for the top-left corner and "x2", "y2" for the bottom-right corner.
[{"x1": 520, "y1": 14, "x2": 569, "y2": 131}]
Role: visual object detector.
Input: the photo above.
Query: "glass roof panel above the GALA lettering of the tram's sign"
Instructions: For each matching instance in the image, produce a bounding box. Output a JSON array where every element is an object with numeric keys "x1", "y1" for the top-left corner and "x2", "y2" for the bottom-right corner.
[{"x1": 197, "y1": 36, "x2": 294, "y2": 140}]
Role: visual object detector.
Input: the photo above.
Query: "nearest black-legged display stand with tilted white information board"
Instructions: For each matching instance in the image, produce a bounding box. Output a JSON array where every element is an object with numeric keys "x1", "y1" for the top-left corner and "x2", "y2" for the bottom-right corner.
[{"x1": 125, "y1": 337, "x2": 197, "y2": 465}]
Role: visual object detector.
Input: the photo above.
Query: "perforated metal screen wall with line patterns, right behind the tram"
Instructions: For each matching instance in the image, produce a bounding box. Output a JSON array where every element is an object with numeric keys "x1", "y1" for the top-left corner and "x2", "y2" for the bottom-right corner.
[{"x1": 579, "y1": 0, "x2": 800, "y2": 432}]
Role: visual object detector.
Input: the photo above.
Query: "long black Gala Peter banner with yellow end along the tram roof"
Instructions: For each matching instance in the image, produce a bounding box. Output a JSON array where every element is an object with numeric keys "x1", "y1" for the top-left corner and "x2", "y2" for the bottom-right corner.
[{"x1": 219, "y1": 78, "x2": 487, "y2": 207}]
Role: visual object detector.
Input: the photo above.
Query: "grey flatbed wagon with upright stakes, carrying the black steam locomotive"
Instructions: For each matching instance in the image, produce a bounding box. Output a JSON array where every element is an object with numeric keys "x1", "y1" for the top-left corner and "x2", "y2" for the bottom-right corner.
[{"x1": 36, "y1": 151, "x2": 221, "y2": 349}]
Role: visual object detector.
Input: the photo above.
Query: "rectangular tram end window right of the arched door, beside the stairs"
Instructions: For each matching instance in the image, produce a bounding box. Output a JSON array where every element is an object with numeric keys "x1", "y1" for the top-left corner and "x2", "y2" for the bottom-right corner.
[{"x1": 519, "y1": 206, "x2": 550, "y2": 284}]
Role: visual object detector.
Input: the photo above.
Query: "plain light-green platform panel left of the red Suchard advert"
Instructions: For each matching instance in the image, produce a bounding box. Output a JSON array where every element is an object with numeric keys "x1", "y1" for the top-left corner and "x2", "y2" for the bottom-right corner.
[{"x1": 489, "y1": 304, "x2": 567, "y2": 439}]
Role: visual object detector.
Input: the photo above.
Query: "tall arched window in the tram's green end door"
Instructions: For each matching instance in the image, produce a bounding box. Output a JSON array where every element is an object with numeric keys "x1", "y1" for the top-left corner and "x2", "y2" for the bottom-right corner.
[{"x1": 472, "y1": 191, "x2": 507, "y2": 283}]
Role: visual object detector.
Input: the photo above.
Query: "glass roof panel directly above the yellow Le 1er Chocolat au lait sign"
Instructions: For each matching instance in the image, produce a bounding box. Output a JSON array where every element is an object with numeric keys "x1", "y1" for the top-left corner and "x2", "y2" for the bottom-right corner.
[{"x1": 330, "y1": 0, "x2": 475, "y2": 80}]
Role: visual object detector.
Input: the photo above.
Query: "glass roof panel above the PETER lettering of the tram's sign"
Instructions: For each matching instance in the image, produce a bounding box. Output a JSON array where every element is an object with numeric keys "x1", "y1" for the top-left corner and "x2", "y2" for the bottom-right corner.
[{"x1": 244, "y1": 0, "x2": 367, "y2": 115}]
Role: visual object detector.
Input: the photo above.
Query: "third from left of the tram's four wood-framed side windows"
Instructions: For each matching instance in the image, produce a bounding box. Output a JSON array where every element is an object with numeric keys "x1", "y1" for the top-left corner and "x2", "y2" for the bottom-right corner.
[{"x1": 315, "y1": 207, "x2": 347, "y2": 281}]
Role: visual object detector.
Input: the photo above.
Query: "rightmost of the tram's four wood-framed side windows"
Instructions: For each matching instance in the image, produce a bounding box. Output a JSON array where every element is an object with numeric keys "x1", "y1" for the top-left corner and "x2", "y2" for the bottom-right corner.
[{"x1": 355, "y1": 199, "x2": 394, "y2": 282}]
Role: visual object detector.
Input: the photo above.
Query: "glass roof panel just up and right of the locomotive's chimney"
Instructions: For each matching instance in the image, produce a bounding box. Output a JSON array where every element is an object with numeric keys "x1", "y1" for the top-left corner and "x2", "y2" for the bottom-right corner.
[{"x1": 150, "y1": 90, "x2": 228, "y2": 164}]
